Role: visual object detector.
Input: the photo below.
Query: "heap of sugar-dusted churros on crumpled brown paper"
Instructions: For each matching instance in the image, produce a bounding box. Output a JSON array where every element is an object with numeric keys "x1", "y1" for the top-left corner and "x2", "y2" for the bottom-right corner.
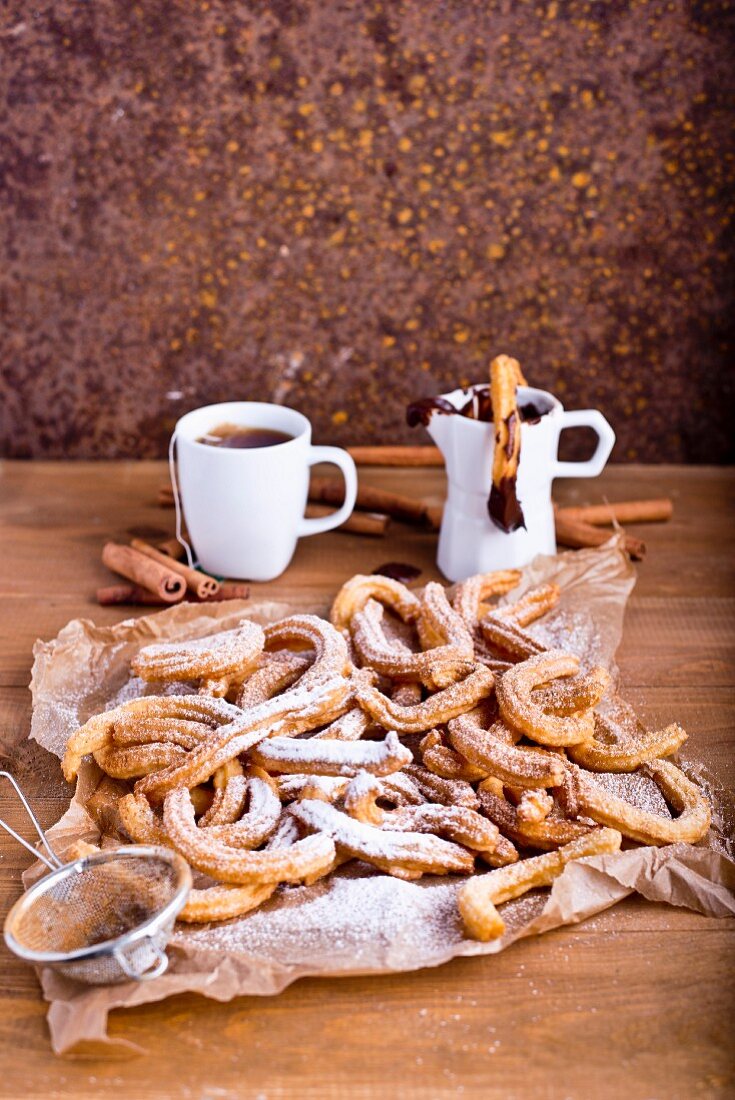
[{"x1": 63, "y1": 571, "x2": 710, "y2": 941}]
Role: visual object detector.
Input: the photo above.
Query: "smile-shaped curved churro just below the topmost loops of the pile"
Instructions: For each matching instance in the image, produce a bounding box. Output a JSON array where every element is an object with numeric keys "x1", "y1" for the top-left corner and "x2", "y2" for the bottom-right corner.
[{"x1": 354, "y1": 664, "x2": 495, "y2": 734}]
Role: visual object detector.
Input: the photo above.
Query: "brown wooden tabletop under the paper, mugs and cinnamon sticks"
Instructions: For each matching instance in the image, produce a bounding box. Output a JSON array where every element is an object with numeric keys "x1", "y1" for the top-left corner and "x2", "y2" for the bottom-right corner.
[{"x1": 0, "y1": 462, "x2": 735, "y2": 1100}]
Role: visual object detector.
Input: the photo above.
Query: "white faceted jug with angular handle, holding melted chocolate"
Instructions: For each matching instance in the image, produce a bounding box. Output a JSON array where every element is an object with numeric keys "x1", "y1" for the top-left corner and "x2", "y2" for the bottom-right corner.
[{"x1": 427, "y1": 386, "x2": 615, "y2": 581}]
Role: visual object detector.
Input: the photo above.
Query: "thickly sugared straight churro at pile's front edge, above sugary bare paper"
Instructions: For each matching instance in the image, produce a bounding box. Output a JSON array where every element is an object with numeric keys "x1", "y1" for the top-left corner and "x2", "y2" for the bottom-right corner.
[{"x1": 290, "y1": 799, "x2": 473, "y2": 879}]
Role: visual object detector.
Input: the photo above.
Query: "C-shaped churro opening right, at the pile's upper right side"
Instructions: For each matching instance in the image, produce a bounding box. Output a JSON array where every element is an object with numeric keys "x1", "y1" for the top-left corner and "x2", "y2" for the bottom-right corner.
[{"x1": 496, "y1": 650, "x2": 607, "y2": 746}]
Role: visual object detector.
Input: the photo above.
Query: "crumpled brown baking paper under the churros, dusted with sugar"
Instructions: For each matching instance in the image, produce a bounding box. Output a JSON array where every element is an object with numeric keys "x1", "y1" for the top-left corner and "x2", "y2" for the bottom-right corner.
[{"x1": 26, "y1": 539, "x2": 735, "y2": 1054}]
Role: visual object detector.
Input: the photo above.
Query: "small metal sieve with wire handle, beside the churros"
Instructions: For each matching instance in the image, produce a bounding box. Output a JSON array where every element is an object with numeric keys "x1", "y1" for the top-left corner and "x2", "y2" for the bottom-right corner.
[{"x1": 0, "y1": 771, "x2": 191, "y2": 986}]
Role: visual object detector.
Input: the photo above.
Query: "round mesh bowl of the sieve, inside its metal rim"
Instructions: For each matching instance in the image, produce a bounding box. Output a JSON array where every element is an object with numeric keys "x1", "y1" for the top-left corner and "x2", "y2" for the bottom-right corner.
[{"x1": 12, "y1": 856, "x2": 179, "y2": 954}]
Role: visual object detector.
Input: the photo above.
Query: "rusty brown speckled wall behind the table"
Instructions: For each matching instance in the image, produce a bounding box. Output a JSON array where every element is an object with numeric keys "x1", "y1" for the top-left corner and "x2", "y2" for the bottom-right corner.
[{"x1": 0, "y1": 0, "x2": 735, "y2": 461}]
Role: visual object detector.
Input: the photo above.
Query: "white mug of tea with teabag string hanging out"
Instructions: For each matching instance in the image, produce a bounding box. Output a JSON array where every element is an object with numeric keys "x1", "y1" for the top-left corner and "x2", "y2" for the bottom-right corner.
[{"x1": 168, "y1": 402, "x2": 358, "y2": 581}]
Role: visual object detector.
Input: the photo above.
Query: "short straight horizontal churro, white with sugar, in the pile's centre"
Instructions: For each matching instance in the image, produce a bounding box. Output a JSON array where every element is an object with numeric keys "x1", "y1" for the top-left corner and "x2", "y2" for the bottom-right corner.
[{"x1": 251, "y1": 732, "x2": 413, "y2": 776}]
